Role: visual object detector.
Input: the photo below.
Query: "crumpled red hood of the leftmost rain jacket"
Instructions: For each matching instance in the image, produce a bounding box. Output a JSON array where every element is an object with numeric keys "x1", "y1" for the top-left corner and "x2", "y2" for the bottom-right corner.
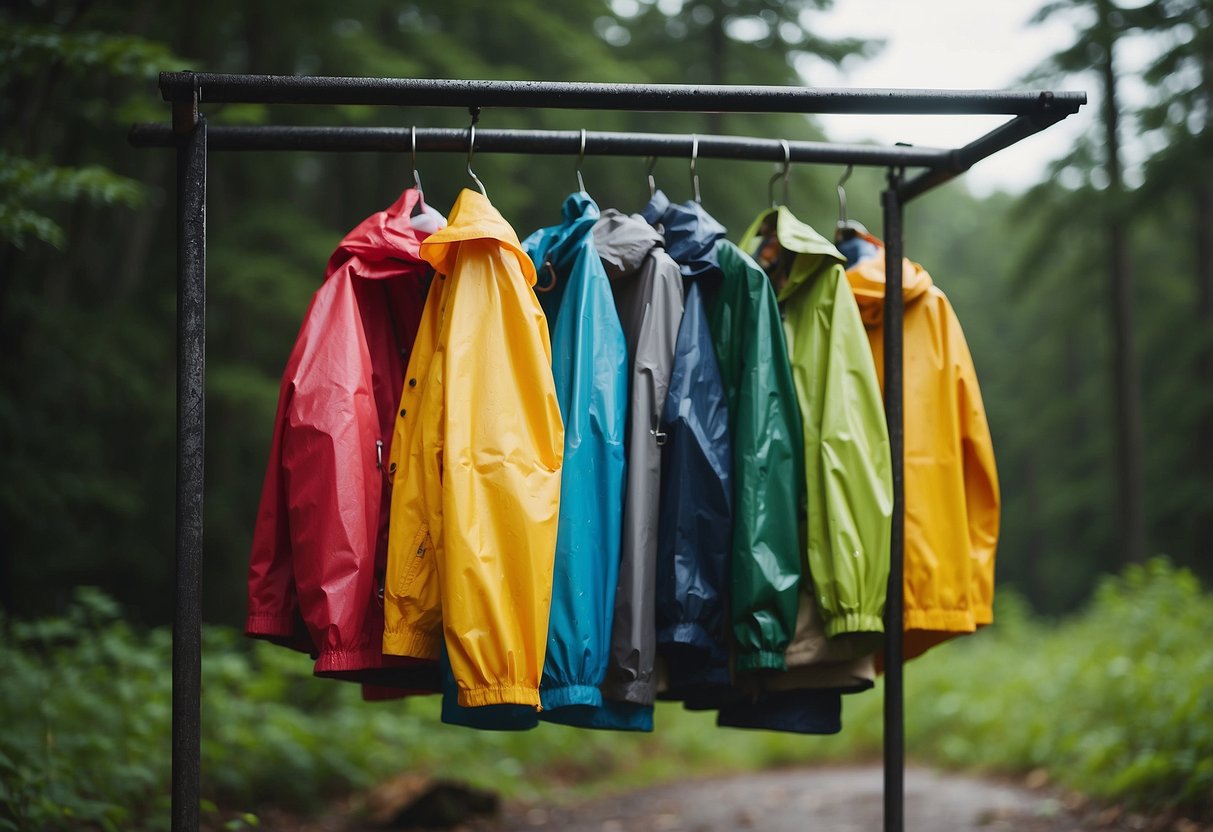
[{"x1": 325, "y1": 188, "x2": 446, "y2": 278}]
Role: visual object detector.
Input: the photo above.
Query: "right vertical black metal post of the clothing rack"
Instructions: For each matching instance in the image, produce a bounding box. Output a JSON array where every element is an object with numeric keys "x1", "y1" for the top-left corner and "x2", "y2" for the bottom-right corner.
[{"x1": 881, "y1": 170, "x2": 905, "y2": 832}]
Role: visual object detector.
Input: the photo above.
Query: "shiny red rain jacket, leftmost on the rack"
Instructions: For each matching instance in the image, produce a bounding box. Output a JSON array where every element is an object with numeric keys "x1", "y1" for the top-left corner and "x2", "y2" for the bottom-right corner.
[{"x1": 245, "y1": 189, "x2": 443, "y2": 696}]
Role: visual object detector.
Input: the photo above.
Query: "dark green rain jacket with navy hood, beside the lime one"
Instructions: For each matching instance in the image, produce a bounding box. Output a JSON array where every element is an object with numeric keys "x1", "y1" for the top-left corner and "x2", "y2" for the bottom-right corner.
[{"x1": 644, "y1": 192, "x2": 804, "y2": 671}]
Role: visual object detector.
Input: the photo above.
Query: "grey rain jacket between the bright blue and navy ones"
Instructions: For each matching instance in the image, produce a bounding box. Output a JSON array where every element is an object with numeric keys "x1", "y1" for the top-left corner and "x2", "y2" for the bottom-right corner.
[{"x1": 593, "y1": 210, "x2": 683, "y2": 719}]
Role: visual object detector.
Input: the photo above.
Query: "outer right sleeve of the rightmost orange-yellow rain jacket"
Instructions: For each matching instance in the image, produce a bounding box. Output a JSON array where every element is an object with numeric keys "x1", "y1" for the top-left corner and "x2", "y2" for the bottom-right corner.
[{"x1": 949, "y1": 307, "x2": 1000, "y2": 626}]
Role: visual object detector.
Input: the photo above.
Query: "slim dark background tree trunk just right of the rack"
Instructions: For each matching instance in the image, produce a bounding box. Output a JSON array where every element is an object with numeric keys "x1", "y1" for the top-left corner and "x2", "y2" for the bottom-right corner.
[{"x1": 1099, "y1": 8, "x2": 1145, "y2": 563}]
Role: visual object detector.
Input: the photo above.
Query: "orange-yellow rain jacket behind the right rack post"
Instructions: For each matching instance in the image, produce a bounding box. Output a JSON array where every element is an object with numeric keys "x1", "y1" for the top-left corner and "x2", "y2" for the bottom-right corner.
[{"x1": 847, "y1": 238, "x2": 1000, "y2": 659}]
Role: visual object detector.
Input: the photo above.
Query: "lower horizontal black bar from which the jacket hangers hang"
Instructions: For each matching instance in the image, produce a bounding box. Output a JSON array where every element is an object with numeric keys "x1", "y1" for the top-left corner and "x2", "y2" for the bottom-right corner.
[{"x1": 130, "y1": 124, "x2": 953, "y2": 167}]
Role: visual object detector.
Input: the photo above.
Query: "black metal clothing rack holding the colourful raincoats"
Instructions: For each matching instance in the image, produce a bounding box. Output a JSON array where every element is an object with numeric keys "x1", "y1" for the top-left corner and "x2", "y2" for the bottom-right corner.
[{"x1": 130, "y1": 72, "x2": 1087, "y2": 832}]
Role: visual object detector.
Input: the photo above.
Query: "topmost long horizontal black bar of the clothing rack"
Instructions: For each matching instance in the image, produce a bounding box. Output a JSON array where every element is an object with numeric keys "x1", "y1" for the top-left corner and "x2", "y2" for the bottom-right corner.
[{"x1": 160, "y1": 72, "x2": 1087, "y2": 115}]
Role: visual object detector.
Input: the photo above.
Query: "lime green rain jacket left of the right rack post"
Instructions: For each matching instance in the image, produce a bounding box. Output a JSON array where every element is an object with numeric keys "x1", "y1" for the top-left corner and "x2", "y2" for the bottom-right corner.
[{"x1": 742, "y1": 207, "x2": 893, "y2": 646}]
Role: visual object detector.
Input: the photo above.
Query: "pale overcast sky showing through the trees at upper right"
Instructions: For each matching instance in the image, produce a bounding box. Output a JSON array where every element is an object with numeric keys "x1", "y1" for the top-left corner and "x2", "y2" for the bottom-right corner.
[{"x1": 803, "y1": 0, "x2": 1095, "y2": 193}]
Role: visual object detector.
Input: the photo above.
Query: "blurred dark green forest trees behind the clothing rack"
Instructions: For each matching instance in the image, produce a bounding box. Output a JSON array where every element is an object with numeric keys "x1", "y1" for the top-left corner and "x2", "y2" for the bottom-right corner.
[{"x1": 0, "y1": 0, "x2": 1213, "y2": 623}]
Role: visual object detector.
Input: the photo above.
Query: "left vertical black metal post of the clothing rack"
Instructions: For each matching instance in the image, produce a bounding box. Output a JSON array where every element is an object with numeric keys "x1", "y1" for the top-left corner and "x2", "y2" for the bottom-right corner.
[{"x1": 172, "y1": 109, "x2": 206, "y2": 832}]
